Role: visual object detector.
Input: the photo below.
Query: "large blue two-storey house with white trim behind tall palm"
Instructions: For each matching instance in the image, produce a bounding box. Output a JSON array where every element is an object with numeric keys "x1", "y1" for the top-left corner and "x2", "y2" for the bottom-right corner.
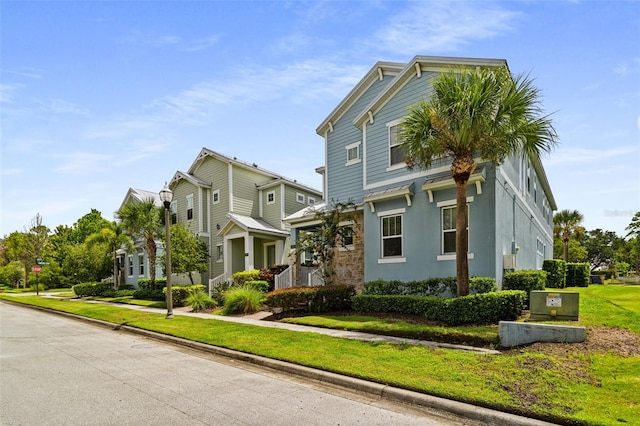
[{"x1": 287, "y1": 56, "x2": 557, "y2": 285}]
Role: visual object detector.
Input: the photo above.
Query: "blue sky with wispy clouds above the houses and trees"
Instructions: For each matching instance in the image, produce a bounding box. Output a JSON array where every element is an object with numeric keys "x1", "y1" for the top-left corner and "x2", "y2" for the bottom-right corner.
[{"x1": 0, "y1": 0, "x2": 640, "y2": 237}]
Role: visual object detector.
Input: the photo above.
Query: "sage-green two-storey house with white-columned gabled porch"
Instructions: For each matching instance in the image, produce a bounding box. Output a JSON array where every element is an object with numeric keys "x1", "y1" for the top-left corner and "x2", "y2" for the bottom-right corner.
[{"x1": 169, "y1": 148, "x2": 322, "y2": 290}]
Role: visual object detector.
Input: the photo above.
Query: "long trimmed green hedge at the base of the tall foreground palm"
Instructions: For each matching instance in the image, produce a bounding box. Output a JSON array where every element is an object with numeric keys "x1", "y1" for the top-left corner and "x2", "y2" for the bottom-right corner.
[{"x1": 352, "y1": 290, "x2": 525, "y2": 325}]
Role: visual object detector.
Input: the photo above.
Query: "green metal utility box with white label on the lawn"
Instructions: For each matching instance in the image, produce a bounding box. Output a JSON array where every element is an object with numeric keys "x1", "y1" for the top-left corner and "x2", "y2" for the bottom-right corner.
[{"x1": 529, "y1": 290, "x2": 580, "y2": 321}]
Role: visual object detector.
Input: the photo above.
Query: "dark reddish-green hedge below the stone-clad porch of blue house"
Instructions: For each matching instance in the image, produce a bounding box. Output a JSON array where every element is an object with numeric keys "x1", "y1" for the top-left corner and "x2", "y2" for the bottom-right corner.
[{"x1": 265, "y1": 285, "x2": 355, "y2": 313}]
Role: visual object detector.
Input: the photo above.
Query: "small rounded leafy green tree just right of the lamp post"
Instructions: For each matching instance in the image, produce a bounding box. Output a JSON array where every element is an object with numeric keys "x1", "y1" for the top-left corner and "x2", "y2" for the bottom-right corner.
[{"x1": 160, "y1": 223, "x2": 209, "y2": 284}]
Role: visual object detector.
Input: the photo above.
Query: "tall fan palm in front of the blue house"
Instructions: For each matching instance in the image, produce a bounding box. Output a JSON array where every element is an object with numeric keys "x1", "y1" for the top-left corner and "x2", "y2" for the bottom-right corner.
[{"x1": 399, "y1": 66, "x2": 557, "y2": 296}]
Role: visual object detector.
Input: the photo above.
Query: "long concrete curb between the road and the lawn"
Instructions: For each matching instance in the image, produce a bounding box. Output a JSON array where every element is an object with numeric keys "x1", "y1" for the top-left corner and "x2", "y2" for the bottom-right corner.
[{"x1": 0, "y1": 299, "x2": 555, "y2": 426}]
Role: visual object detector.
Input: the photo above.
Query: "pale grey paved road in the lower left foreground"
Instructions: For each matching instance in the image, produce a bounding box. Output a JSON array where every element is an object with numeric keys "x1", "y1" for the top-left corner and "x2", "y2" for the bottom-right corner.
[{"x1": 0, "y1": 303, "x2": 474, "y2": 426}]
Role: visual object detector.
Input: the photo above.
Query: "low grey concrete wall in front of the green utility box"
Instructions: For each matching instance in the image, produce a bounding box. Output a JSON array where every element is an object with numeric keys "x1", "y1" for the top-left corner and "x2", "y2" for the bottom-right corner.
[{"x1": 498, "y1": 321, "x2": 587, "y2": 347}]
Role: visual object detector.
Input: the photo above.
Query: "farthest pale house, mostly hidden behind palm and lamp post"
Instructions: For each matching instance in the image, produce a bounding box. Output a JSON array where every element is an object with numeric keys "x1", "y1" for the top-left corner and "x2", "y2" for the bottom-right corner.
[{"x1": 117, "y1": 188, "x2": 164, "y2": 288}]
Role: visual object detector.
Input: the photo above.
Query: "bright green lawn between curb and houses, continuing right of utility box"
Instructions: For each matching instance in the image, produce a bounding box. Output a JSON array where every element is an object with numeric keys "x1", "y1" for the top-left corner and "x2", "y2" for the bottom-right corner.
[{"x1": 0, "y1": 286, "x2": 640, "y2": 425}]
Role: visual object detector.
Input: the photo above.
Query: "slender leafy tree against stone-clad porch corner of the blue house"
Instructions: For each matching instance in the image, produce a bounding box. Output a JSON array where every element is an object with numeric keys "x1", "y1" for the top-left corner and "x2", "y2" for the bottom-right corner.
[{"x1": 298, "y1": 201, "x2": 355, "y2": 285}]
